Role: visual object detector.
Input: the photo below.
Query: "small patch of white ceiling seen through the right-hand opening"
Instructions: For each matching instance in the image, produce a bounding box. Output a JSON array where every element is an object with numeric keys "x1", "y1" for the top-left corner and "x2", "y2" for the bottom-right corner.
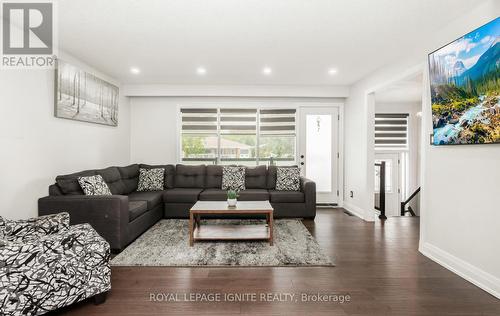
[{"x1": 375, "y1": 74, "x2": 423, "y2": 103}]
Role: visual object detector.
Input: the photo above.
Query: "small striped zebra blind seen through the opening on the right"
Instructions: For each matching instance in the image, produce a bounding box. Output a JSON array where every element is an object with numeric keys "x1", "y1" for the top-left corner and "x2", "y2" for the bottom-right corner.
[{"x1": 375, "y1": 113, "x2": 408, "y2": 150}]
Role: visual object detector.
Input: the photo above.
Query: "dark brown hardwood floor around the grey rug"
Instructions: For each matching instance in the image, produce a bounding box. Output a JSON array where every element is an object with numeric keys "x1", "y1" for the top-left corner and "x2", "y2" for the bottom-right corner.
[{"x1": 53, "y1": 209, "x2": 500, "y2": 316}]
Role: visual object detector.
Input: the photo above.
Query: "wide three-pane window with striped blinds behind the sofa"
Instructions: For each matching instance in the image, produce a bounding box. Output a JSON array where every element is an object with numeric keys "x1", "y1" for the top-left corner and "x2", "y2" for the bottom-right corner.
[{"x1": 181, "y1": 108, "x2": 296, "y2": 165}]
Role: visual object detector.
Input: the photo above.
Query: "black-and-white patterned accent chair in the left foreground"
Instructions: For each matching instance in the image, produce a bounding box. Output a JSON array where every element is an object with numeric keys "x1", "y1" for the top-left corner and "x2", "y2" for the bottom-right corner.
[{"x1": 0, "y1": 213, "x2": 111, "y2": 315}]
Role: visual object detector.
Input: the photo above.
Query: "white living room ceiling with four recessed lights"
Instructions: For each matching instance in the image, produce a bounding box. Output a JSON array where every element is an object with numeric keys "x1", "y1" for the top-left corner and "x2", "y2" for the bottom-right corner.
[{"x1": 58, "y1": 0, "x2": 482, "y2": 85}]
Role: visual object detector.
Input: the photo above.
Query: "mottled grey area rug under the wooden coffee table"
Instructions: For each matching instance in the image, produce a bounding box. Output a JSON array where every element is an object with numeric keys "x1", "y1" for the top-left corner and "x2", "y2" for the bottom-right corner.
[{"x1": 111, "y1": 219, "x2": 333, "y2": 267}]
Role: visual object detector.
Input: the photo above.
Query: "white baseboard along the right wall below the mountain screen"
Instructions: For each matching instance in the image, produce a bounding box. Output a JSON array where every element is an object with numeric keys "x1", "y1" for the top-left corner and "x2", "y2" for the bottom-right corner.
[{"x1": 418, "y1": 243, "x2": 500, "y2": 299}]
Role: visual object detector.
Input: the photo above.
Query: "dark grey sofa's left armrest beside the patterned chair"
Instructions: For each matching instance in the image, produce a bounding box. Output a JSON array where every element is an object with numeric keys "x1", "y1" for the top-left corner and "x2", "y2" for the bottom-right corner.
[{"x1": 38, "y1": 195, "x2": 129, "y2": 249}]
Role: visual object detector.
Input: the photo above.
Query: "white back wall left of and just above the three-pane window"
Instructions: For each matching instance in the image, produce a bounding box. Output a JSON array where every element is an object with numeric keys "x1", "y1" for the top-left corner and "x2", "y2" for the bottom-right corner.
[{"x1": 130, "y1": 97, "x2": 344, "y2": 164}]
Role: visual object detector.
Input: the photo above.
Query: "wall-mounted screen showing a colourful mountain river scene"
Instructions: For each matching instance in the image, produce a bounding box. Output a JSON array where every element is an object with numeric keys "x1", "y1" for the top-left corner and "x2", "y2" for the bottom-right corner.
[{"x1": 429, "y1": 18, "x2": 500, "y2": 145}]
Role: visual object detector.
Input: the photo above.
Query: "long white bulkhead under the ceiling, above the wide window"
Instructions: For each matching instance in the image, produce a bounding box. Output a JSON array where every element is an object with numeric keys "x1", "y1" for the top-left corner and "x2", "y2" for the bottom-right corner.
[{"x1": 121, "y1": 84, "x2": 349, "y2": 98}]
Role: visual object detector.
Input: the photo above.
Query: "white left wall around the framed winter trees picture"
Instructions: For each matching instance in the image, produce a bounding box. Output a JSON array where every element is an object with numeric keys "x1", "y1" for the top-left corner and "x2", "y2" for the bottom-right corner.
[{"x1": 0, "y1": 54, "x2": 130, "y2": 219}]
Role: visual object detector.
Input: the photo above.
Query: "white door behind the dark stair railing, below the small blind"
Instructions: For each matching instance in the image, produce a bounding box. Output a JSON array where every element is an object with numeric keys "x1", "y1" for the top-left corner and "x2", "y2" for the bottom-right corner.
[{"x1": 375, "y1": 153, "x2": 400, "y2": 217}]
